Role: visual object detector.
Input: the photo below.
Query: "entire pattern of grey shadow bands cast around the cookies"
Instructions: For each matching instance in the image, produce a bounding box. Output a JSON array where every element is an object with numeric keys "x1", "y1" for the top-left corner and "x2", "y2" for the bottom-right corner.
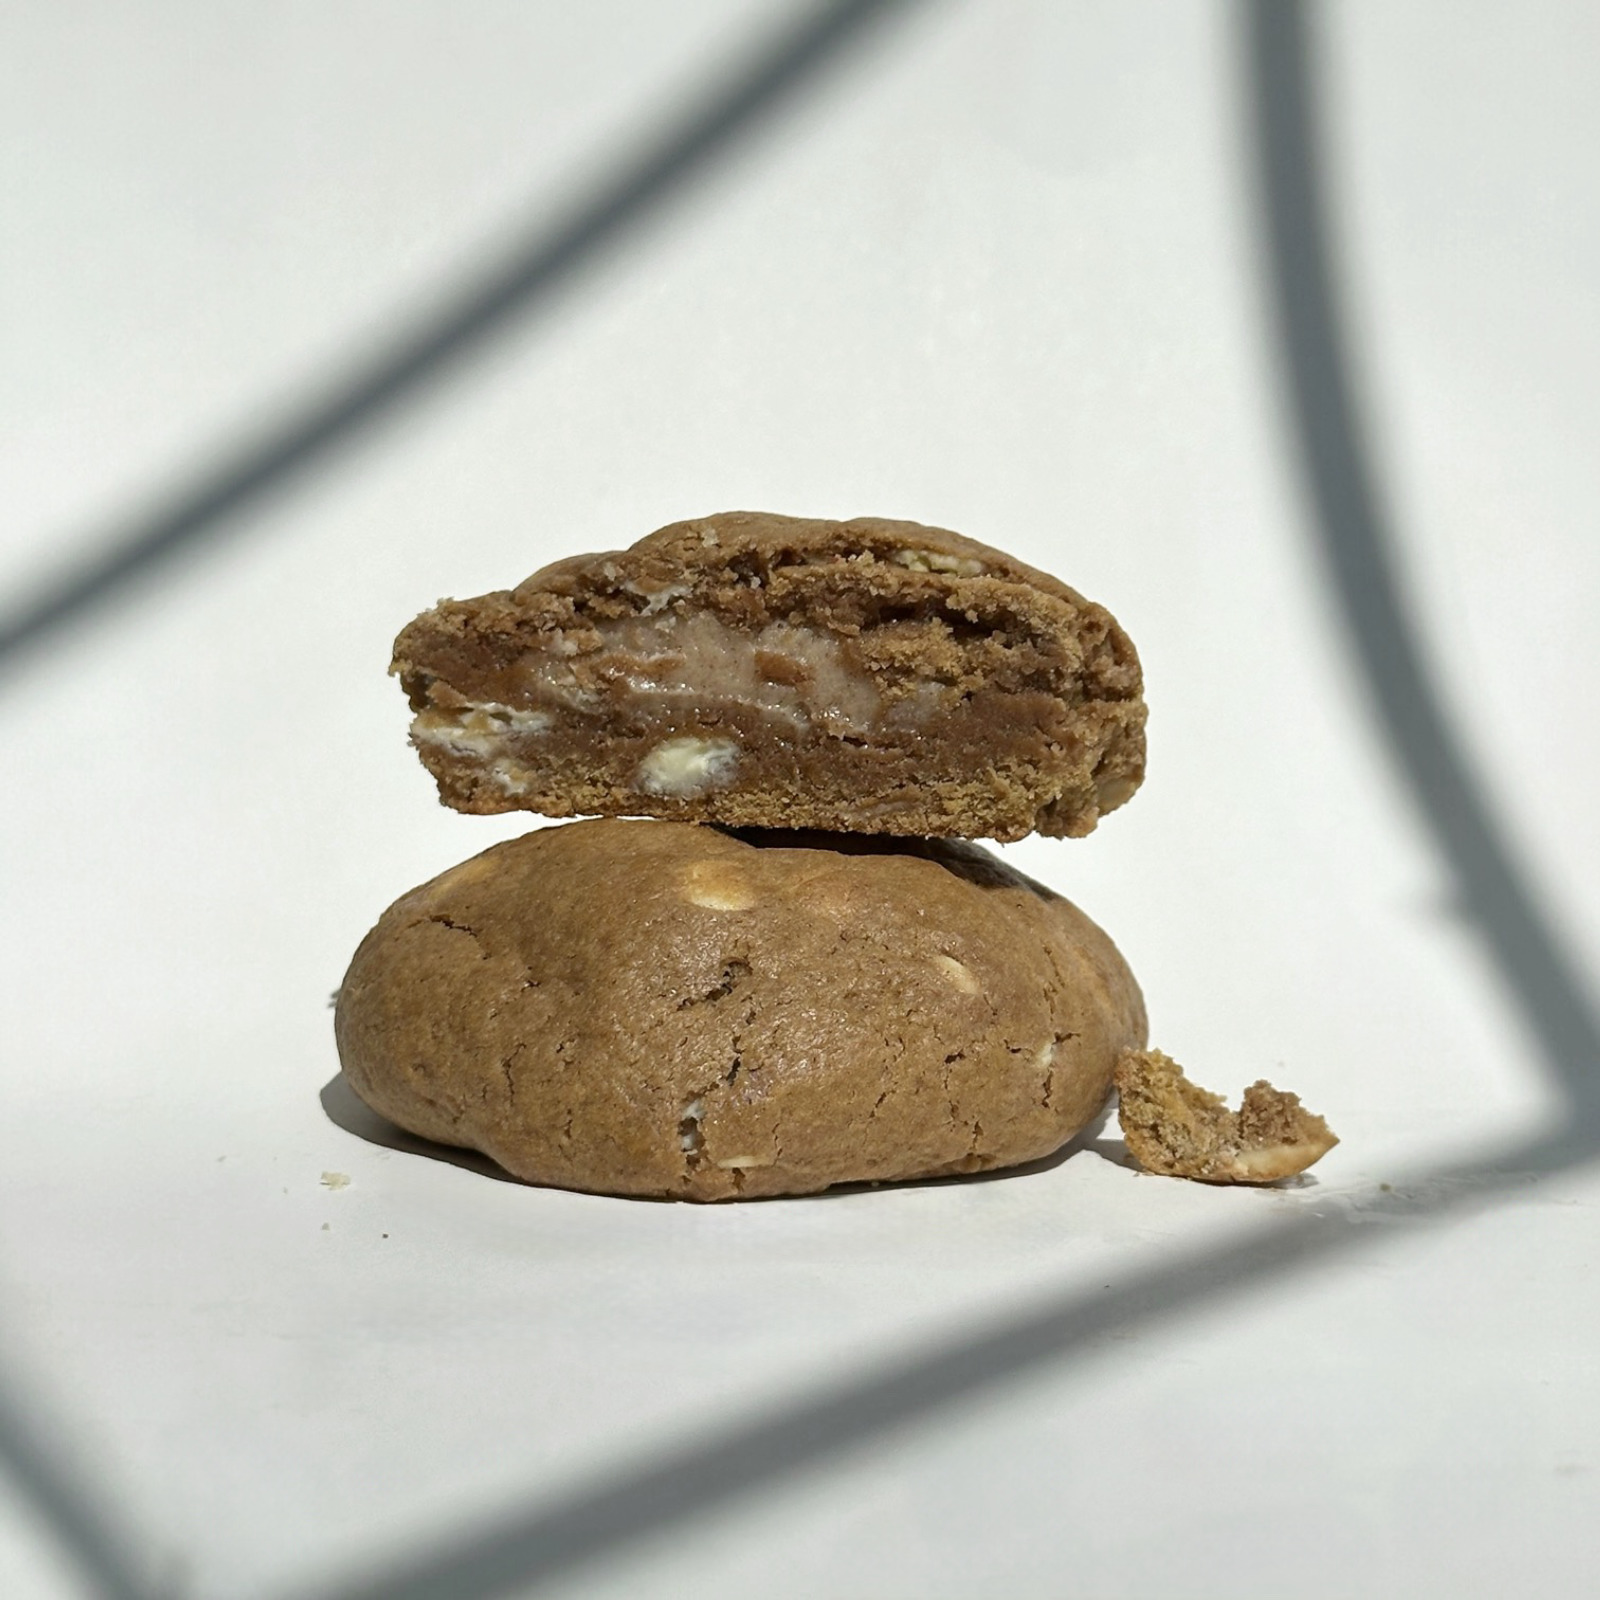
[{"x1": 0, "y1": 0, "x2": 1600, "y2": 1600}]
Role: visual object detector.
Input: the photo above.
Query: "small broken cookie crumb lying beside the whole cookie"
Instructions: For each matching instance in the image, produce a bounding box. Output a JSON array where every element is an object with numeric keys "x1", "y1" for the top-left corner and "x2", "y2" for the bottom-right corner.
[{"x1": 1115, "y1": 1050, "x2": 1339, "y2": 1184}]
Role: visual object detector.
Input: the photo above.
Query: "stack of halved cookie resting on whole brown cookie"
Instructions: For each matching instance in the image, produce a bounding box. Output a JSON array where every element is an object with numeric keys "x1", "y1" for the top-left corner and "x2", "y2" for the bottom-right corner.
[{"x1": 336, "y1": 512, "x2": 1146, "y2": 1200}]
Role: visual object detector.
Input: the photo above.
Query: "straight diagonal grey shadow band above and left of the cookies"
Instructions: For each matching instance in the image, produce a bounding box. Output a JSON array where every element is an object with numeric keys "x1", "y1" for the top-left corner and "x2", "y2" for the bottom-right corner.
[{"x1": 0, "y1": 0, "x2": 925, "y2": 667}]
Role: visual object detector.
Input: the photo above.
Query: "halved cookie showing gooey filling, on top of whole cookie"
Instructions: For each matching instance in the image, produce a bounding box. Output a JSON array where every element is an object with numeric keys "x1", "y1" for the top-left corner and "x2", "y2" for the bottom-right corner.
[{"x1": 390, "y1": 512, "x2": 1146, "y2": 840}]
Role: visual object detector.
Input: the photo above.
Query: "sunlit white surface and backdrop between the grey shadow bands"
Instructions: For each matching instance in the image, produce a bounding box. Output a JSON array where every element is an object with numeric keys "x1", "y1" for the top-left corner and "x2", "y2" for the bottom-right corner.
[{"x1": 0, "y1": 0, "x2": 1600, "y2": 1597}]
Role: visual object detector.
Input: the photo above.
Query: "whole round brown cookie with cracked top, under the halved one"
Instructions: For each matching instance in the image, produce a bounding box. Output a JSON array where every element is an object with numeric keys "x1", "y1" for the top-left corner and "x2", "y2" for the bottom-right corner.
[{"x1": 334, "y1": 819, "x2": 1146, "y2": 1200}]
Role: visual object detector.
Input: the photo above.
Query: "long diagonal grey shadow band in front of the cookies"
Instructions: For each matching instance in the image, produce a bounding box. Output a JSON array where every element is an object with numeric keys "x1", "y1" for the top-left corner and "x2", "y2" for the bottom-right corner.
[{"x1": 297, "y1": 1130, "x2": 1600, "y2": 1600}]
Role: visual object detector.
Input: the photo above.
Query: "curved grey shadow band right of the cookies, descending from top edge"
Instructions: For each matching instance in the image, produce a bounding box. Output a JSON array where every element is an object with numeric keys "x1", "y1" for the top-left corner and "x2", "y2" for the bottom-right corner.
[{"x1": 1245, "y1": 0, "x2": 1600, "y2": 1117}]
